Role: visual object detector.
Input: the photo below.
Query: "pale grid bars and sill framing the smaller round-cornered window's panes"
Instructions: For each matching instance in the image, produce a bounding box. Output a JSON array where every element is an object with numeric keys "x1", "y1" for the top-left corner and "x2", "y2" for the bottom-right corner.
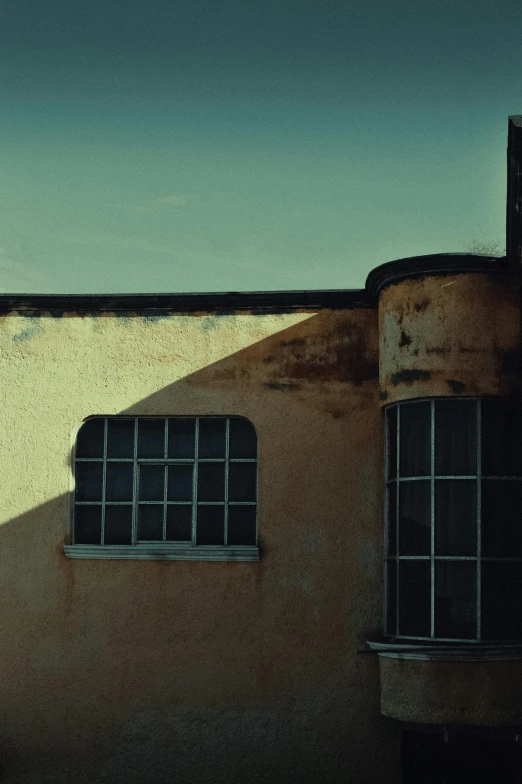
[{"x1": 65, "y1": 415, "x2": 259, "y2": 560}]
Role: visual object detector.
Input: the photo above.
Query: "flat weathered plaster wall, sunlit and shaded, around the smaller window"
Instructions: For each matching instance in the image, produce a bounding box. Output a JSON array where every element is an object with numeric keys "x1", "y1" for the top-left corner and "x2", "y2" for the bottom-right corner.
[{"x1": 0, "y1": 309, "x2": 398, "y2": 784}]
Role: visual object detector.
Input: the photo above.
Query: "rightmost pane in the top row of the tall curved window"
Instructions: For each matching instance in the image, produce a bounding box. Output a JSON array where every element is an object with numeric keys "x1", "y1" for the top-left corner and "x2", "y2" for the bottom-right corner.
[{"x1": 482, "y1": 400, "x2": 522, "y2": 476}]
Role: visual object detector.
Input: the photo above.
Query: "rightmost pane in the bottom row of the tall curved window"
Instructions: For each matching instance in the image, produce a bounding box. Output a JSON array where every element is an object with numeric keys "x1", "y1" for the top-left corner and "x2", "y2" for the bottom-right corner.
[{"x1": 482, "y1": 561, "x2": 522, "y2": 640}]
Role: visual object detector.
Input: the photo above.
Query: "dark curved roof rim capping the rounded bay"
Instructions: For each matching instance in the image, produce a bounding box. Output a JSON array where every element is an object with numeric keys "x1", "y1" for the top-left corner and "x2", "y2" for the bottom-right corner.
[{"x1": 365, "y1": 253, "x2": 517, "y2": 297}]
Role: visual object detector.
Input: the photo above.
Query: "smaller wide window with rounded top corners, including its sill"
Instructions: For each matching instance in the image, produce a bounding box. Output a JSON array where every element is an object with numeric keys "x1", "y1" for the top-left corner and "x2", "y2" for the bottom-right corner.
[{"x1": 66, "y1": 416, "x2": 258, "y2": 560}]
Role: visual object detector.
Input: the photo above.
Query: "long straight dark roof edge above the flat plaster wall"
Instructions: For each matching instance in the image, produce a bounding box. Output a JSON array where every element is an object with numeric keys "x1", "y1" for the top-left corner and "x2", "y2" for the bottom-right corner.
[{"x1": 0, "y1": 289, "x2": 377, "y2": 315}]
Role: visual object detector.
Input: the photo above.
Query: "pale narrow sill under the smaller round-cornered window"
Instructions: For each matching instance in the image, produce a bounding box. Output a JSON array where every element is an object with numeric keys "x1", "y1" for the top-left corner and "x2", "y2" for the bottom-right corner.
[{"x1": 63, "y1": 543, "x2": 259, "y2": 561}]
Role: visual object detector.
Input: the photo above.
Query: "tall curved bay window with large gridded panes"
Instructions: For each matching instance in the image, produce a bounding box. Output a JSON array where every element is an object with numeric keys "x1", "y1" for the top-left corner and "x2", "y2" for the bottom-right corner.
[{"x1": 385, "y1": 398, "x2": 522, "y2": 642}]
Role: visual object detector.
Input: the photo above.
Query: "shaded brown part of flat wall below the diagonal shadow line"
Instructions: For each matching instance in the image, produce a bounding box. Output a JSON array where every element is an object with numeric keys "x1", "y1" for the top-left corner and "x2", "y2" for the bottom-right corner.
[{"x1": 0, "y1": 310, "x2": 389, "y2": 782}]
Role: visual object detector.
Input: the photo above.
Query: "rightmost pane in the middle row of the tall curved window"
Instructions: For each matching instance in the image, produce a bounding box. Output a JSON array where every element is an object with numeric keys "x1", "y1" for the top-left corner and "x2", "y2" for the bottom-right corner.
[{"x1": 482, "y1": 479, "x2": 522, "y2": 558}]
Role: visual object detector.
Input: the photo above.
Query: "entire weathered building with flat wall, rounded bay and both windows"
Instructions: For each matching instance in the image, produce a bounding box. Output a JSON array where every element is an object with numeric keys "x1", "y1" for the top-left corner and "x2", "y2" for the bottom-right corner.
[{"x1": 0, "y1": 118, "x2": 522, "y2": 784}]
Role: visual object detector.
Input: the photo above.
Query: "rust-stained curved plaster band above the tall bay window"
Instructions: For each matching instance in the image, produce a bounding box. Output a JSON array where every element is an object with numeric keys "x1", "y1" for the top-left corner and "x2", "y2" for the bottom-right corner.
[{"x1": 379, "y1": 273, "x2": 520, "y2": 404}]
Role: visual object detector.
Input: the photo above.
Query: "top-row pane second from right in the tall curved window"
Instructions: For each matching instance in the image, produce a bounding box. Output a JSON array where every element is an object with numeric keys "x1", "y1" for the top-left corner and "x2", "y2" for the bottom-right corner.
[{"x1": 435, "y1": 400, "x2": 477, "y2": 475}]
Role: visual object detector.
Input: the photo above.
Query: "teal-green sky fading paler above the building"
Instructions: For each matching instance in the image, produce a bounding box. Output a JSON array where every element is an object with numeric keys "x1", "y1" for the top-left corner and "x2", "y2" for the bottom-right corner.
[{"x1": 0, "y1": 0, "x2": 522, "y2": 294}]
